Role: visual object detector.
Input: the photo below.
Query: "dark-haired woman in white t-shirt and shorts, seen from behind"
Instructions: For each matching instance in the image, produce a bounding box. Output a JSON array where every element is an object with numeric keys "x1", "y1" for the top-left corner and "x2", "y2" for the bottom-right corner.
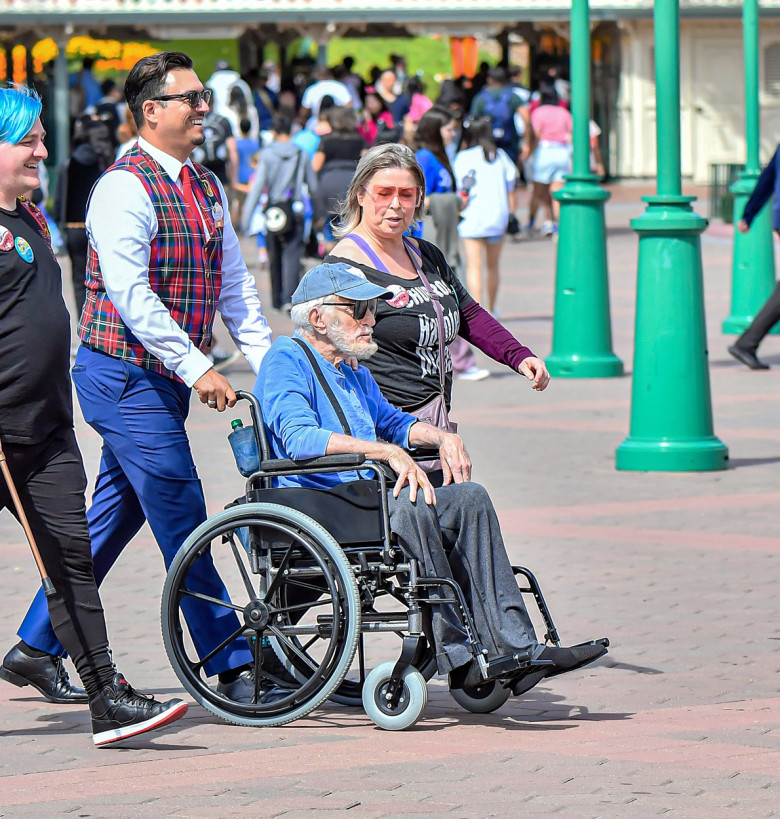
[{"x1": 453, "y1": 117, "x2": 517, "y2": 313}]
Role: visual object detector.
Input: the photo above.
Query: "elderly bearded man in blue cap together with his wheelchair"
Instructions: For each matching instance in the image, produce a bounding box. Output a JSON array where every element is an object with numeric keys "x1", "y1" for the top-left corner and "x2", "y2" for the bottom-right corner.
[{"x1": 163, "y1": 264, "x2": 609, "y2": 729}]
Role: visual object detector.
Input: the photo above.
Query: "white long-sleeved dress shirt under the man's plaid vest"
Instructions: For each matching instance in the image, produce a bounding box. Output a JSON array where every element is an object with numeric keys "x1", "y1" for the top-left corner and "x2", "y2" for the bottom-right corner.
[{"x1": 86, "y1": 137, "x2": 271, "y2": 387}]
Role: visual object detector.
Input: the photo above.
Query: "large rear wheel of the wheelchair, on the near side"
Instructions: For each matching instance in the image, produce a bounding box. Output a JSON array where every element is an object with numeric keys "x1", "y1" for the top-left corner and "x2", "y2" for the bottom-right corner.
[{"x1": 162, "y1": 503, "x2": 360, "y2": 726}]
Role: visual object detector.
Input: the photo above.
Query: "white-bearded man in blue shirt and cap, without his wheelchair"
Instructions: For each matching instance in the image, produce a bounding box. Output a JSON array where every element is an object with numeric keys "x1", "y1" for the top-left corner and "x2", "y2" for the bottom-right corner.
[{"x1": 254, "y1": 263, "x2": 606, "y2": 694}]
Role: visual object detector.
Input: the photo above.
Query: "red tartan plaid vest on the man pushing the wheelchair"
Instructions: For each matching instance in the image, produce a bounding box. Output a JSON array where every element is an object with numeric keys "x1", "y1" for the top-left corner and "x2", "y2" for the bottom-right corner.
[{"x1": 79, "y1": 145, "x2": 224, "y2": 381}]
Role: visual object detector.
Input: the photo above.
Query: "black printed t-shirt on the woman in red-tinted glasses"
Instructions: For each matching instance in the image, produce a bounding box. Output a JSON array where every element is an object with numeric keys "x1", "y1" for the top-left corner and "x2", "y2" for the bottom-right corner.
[{"x1": 325, "y1": 240, "x2": 473, "y2": 412}]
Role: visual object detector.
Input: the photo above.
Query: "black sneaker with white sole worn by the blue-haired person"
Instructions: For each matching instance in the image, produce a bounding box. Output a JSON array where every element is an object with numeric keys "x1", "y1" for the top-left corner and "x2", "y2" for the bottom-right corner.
[{"x1": 89, "y1": 674, "x2": 187, "y2": 748}]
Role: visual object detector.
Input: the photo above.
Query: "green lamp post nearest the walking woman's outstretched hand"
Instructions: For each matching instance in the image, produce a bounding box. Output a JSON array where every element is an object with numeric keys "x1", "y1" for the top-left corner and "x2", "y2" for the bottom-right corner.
[{"x1": 546, "y1": 0, "x2": 623, "y2": 378}]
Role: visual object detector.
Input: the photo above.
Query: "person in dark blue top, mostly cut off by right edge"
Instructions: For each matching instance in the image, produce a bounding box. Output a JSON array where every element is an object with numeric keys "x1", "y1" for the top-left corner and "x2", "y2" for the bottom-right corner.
[{"x1": 729, "y1": 146, "x2": 780, "y2": 370}]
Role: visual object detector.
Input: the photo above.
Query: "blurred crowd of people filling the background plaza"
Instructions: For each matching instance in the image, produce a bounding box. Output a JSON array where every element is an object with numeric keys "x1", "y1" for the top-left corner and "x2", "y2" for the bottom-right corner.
[{"x1": 54, "y1": 55, "x2": 604, "y2": 380}]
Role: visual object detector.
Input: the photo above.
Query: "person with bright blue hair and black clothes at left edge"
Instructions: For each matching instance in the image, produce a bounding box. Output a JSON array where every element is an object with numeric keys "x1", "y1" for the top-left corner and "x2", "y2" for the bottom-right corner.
[{"x1": 0, "y1": 85, "x2": 187, "y2": 747}]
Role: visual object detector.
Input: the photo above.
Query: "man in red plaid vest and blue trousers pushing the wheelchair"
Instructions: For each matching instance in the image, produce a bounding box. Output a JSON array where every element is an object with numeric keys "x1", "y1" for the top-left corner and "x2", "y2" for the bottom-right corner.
[{"x1": 9, "y1": 52, "x2": 271, "y2": 700}]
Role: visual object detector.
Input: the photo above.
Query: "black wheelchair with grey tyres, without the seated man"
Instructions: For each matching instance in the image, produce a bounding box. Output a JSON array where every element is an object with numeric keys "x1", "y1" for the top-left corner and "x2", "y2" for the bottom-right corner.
[{"x1": 162, "y1": 391, "x2": 609, "y2": 730}]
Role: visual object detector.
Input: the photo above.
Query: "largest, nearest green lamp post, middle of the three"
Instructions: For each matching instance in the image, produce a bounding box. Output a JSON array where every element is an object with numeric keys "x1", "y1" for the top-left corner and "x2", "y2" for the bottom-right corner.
[{"x1": 616, "y1": 0, "x2": 728, "y2": 472}]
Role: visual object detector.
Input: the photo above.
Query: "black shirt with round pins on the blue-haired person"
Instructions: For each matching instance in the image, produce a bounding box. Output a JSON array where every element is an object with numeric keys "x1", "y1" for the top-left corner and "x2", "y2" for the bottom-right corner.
[{"x1": 0, "y1": 203, "x2": 73, "y2": 444}]
